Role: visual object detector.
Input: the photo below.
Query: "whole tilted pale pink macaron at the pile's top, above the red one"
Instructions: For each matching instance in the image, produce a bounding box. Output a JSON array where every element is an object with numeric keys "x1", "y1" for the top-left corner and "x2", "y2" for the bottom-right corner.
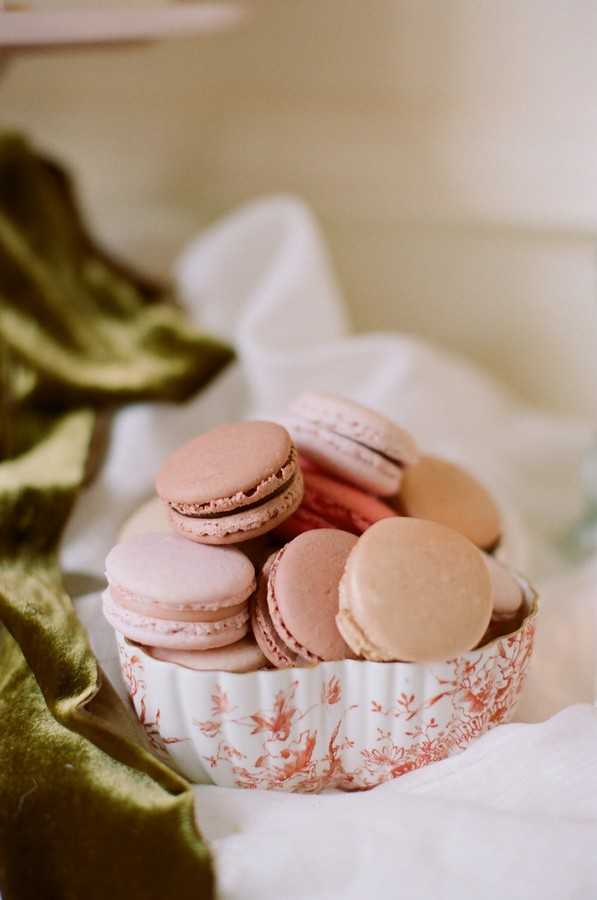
[{"x1": 284, "y1": 393, "x2": 419, "y2": 497}]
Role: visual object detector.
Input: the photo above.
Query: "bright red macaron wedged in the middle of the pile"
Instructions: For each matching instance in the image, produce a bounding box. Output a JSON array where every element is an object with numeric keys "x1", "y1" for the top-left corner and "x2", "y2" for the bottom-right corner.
[{"x1": 276, "y1": 468, "x2": 396, "y2": 540}]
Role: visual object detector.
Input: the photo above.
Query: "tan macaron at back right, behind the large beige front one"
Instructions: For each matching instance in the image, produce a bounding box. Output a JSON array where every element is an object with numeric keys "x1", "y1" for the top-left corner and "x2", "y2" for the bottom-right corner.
[{"x1": 397, "y1": 456, "x2": 502, "y2": 551}]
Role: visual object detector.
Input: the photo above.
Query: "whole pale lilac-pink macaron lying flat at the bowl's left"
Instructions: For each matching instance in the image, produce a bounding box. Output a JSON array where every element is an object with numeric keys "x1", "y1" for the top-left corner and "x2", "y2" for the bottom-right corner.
[{"x1": 103, "y1": 533, "x2": 255, "y2": 650}]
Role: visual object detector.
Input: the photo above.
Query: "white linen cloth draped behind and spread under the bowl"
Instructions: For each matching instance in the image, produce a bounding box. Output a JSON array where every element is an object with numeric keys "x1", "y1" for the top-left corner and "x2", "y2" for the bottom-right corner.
[{"x1": 63, "y1": 197, "x2": 597, "y2": 900}]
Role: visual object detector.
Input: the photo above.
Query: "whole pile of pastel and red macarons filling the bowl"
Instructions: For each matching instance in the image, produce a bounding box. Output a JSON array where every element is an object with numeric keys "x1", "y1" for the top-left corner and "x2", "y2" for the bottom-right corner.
[{"x1": 104, "y1": 393, "x2": 524, "y2": 672}]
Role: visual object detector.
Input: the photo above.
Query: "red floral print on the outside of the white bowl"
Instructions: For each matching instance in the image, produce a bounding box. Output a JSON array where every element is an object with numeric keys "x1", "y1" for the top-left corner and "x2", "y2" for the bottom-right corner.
[{"x1": 121, "y1": 618, "x2": 534, "y2": 793}]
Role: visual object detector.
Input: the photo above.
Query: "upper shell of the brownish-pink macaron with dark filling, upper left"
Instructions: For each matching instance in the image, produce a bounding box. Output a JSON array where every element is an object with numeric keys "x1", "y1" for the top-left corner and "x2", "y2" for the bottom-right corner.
[{"x1": 156, "y1": 421, "x2": 296, "y2": 512}]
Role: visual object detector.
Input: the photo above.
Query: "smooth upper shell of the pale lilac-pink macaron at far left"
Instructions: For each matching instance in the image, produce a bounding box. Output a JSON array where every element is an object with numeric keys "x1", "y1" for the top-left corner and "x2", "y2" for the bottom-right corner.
[{"x1": 106, "y1": 533, "x2": 255, "y2": 618}]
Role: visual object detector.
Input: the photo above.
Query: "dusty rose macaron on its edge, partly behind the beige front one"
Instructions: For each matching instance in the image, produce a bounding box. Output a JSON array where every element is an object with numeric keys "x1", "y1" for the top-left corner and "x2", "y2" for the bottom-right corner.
[{"x1": 252, "y1": 529, "x2": 357, "y2": 668}]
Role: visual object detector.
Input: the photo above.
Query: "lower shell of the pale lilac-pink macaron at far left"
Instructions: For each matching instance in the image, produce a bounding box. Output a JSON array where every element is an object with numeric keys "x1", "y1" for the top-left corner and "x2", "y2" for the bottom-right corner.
[{"x1": 102, "y1": 590, "x2": 249, "y2": 650}]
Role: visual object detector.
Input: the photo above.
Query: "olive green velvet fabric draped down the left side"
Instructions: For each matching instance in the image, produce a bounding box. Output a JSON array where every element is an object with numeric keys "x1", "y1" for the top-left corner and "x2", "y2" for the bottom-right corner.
[{"x1": 0, "y1": 135, "x2": 231, "y2": 900}]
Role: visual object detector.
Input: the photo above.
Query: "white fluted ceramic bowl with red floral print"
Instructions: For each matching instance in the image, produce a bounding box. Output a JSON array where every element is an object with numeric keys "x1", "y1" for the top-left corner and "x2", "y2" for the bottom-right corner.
[{"x1": 117, "y1": 579, "x2": 538, "y2": 792}]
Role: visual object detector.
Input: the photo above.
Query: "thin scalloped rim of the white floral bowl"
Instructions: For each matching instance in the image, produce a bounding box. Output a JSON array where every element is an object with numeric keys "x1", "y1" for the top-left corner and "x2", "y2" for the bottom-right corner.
[{"x1": 114, "y1": 570, "x2": 540, "y2": 679}]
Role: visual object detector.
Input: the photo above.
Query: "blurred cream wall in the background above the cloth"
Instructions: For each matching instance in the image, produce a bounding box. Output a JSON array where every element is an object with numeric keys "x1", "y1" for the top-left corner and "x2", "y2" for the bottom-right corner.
[{"x1": 0, "y1": 0, "x2": 597, "y2": 415}]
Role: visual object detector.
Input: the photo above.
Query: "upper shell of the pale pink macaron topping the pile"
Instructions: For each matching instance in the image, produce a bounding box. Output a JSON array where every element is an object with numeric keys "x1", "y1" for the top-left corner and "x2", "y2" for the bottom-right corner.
[{"x1": 290, "y1": 392, "x2": 419, "y2": 466}]
